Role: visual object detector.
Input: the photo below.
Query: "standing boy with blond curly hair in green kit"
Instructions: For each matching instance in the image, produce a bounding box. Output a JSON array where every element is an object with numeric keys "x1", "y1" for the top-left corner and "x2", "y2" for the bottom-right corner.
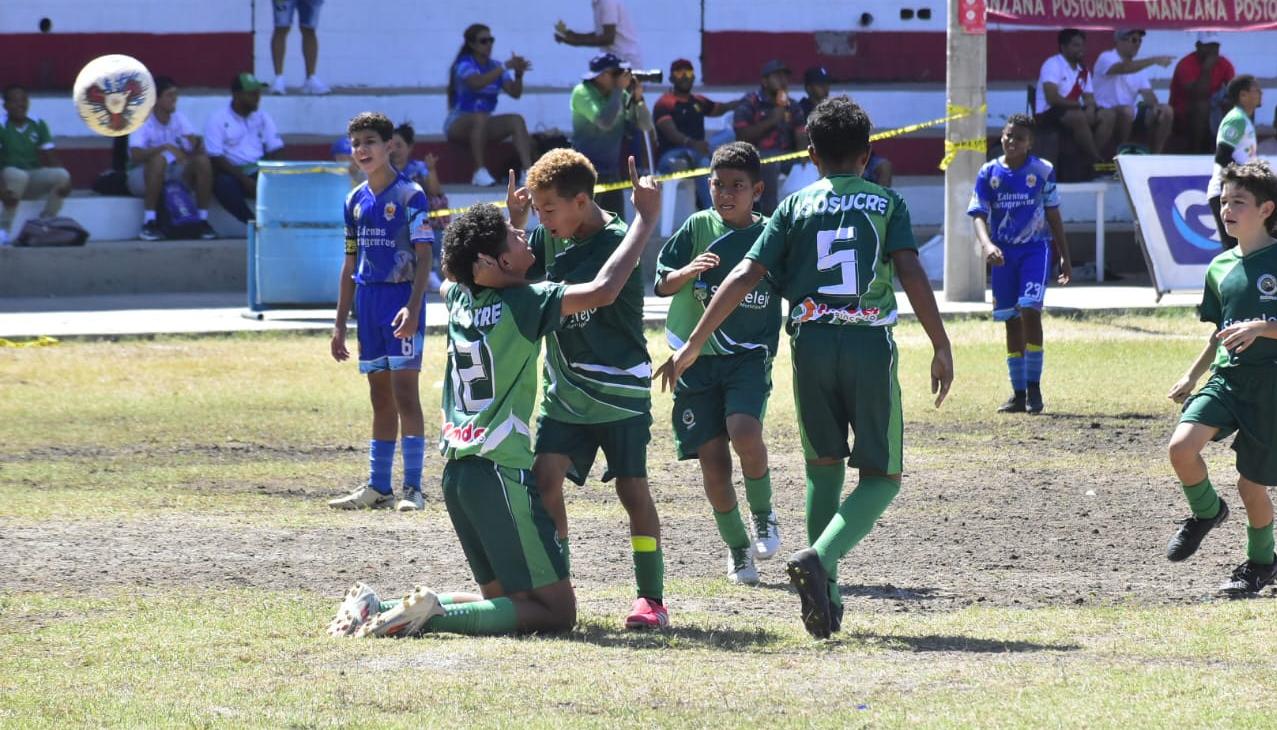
[{"x1": 507, "y1": 149, "x2": 669, "y2": 629}]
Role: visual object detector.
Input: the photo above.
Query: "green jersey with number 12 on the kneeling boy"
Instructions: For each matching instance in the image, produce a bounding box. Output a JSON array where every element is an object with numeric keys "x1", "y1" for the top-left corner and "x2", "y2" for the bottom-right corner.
[{"x1": 439, "y1": 283, "x2": 566, "y2": 468}]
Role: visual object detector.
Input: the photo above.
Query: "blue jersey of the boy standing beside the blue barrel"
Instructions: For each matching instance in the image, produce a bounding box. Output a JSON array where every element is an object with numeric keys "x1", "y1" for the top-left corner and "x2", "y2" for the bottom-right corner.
[{"x1": 346, "y1": 174, "x2": 434, "y2": 286}]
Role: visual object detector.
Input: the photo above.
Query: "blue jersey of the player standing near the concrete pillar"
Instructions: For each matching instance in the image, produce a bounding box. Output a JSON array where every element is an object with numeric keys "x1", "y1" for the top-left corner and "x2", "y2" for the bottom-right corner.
[{"x1": 967, "y1": 154, "x2": 1060, "y2": 246}]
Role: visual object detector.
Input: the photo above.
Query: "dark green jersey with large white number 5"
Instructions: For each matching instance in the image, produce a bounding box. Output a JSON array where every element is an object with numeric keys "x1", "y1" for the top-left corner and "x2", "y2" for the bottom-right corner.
[{"x1": 744, "y1": 174, "x2": 918, "y2": 333}]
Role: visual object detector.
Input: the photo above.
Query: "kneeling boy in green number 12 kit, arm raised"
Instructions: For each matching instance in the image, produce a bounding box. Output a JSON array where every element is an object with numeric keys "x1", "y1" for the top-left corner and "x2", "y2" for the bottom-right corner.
[{"x1": 328, "y1": 158, "x2": 660, "y2": 637}]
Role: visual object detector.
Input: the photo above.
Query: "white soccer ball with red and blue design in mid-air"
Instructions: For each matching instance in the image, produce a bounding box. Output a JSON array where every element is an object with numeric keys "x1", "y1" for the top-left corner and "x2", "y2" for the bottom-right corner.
[{"x1": 72, "y1": 54, "x2": 156, "y2": 137}]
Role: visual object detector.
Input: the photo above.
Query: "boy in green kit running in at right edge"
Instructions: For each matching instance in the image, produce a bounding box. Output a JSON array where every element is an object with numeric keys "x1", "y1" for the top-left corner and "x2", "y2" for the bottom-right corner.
[{"x1": 1166, "y1": 162, "x2": 1277, "y2": 595}]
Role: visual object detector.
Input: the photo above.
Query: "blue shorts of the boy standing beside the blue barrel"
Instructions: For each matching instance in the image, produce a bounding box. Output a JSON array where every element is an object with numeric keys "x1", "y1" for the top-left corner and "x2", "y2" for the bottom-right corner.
[{"x1": 355, "y1": 283, "x2": 425, "y2": 375}]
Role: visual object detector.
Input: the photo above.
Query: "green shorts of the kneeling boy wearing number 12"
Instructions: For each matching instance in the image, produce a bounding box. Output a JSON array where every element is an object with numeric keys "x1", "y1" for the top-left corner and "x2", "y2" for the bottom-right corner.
[{"x1": 443, "y1": 457, "x2": 567, "y2": 595}]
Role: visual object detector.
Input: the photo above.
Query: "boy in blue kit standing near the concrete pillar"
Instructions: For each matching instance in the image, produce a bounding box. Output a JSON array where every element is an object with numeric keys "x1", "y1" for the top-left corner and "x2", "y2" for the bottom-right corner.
[{"x1": 967, "y1": 114, "x2": 1073, "y2": 413}]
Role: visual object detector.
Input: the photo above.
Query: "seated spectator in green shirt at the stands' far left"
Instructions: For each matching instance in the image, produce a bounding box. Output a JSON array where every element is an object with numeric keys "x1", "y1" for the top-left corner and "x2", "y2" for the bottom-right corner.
[{"x1": 0, "y1": 84, "x2": 72, "y2": 245}]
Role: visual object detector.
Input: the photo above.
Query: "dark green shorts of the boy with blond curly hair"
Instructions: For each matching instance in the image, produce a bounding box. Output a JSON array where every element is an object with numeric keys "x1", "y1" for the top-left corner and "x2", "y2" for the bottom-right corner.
[{"x1": 535, "y1": 413, "x2": 651, "y2": 484}]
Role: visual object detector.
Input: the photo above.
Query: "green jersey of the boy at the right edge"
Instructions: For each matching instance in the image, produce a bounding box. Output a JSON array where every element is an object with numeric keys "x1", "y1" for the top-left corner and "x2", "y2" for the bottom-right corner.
[{"x1": 1198, "y1": 244, "x2": 1277, "y2": 368}]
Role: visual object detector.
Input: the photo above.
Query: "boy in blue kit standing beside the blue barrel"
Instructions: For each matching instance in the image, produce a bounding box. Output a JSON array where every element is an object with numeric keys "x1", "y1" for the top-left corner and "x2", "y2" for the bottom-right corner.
[{"x1": 328, "y1": 112, "x2": 434, "y2": 512}]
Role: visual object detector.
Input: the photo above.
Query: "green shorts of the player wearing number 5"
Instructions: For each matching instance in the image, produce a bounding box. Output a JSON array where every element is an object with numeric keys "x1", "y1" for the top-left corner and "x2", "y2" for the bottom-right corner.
[{"x1": 789, "y1": 324, "x2": 904, "y2": 475}]
